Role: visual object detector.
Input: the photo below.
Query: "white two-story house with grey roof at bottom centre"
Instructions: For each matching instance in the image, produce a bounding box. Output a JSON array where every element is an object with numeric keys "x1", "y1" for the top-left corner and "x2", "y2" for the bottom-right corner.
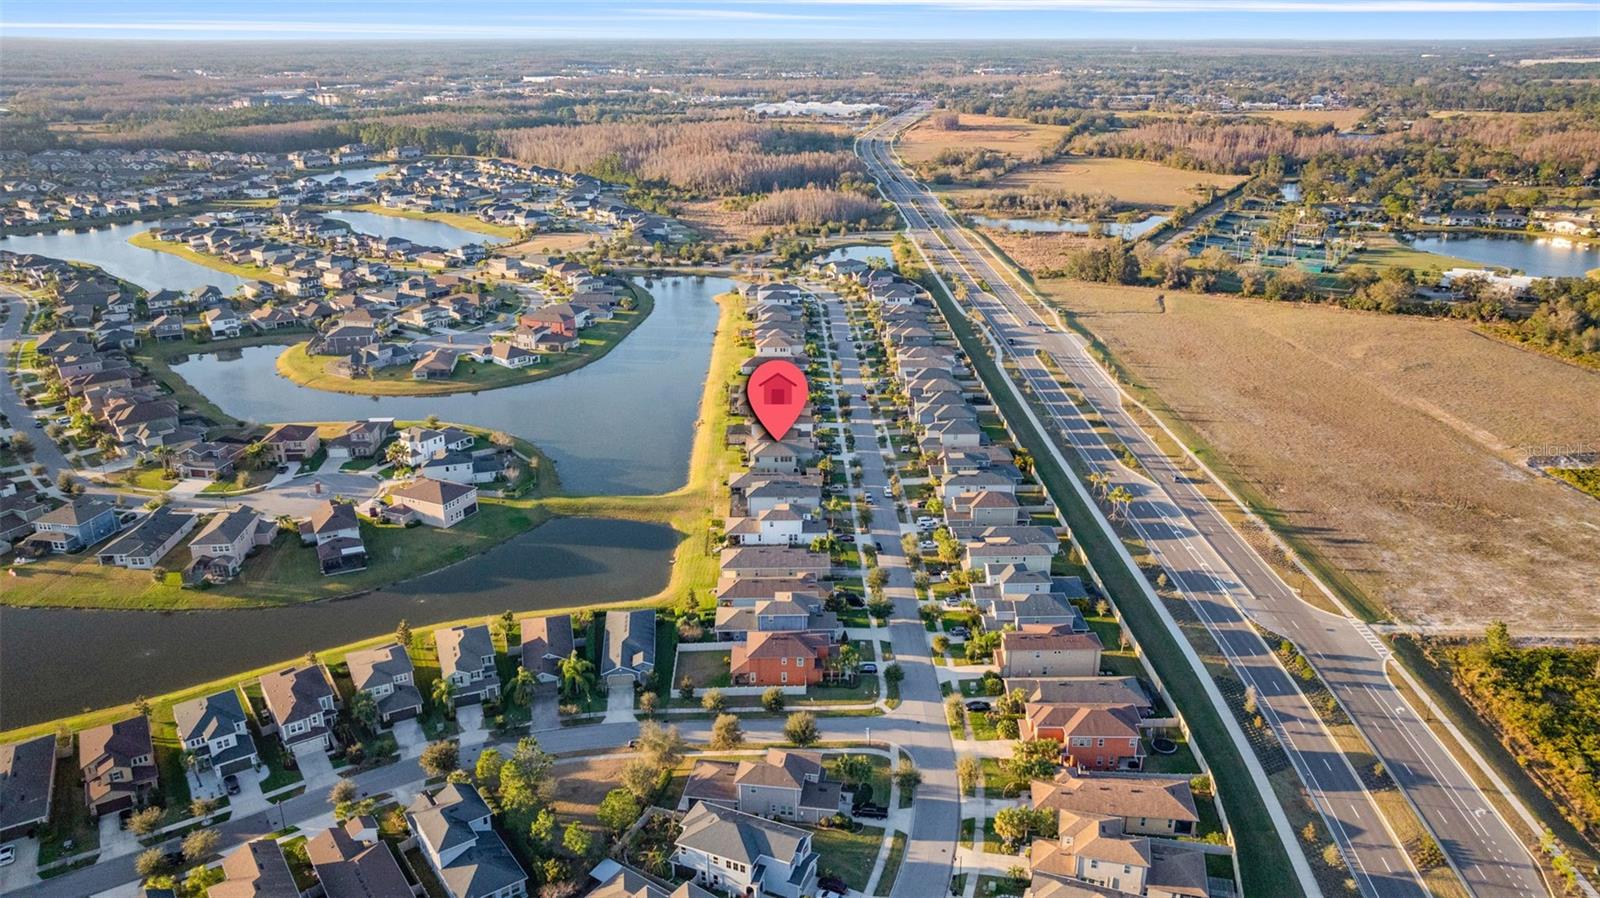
[{"x1": 672, "y1": 802, "x2": 819, "y2": 898}]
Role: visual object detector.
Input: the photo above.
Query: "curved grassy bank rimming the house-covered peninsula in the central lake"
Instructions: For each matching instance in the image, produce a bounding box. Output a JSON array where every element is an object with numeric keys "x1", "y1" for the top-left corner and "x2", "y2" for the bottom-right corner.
[{"x1": 277, "y1": 281, "x2": 656, "y2": 395}]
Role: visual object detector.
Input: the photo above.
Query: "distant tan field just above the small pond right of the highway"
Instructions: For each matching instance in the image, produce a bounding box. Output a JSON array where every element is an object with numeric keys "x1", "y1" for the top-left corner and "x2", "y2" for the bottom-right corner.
[{"x1": 941, "y1": 155, "x2": 1245, "y2": 208}]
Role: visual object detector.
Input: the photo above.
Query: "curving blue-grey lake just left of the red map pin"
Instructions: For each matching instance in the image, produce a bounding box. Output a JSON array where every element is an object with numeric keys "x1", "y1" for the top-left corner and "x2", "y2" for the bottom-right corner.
[{"x1": 173, "y1": 277, "x2": 736, "y2": 493}]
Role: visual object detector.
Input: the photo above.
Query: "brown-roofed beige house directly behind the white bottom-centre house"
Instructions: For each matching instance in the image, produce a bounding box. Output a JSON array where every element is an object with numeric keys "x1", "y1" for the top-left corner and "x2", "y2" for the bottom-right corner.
[{"x1": 678, "y1": 749, "x2": 850, "y2": 824}]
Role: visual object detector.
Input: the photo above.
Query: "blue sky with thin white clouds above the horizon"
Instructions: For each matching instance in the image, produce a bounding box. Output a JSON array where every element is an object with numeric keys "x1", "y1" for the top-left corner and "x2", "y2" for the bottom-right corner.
[{"x1": 0, "y1": 0, "x2": 1600, "y2": 41}]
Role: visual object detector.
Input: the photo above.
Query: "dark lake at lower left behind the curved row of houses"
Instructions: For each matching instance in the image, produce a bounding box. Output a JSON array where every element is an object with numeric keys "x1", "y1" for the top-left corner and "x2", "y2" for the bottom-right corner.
[{"x1": 0, "y1": 517, "x2": 677, "y2": 728}]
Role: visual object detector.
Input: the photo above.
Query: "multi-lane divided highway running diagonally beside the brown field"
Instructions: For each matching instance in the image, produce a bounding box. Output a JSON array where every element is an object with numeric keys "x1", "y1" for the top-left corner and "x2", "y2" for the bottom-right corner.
[{"x1": 858, "y1": 110, "x2": 1546, "y2": 898}]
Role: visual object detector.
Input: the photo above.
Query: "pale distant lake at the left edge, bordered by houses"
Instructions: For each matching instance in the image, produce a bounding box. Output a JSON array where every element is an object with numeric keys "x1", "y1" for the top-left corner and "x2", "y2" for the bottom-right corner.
[{"x1": 0, "y1": 221, "x2": 250, "y2": 293}]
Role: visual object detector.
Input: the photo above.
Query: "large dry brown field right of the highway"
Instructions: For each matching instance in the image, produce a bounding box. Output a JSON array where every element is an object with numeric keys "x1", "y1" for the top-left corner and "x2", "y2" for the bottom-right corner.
[{"x1": 1042, "y1": 282, "x2": 1600, "y2": 635}]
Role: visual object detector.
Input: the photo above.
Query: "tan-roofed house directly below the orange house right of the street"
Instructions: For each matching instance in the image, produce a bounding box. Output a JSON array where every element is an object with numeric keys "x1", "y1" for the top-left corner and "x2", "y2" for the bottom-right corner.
[{"x1": 1029, "y1": 772, "x2": 1200, "y2": 836}]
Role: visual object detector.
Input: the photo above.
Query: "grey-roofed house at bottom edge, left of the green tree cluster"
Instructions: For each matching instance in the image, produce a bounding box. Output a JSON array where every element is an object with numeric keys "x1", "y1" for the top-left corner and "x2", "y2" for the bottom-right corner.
[{"x1": 405, "y1": 783, "x2": 528, "y2": 898}]
